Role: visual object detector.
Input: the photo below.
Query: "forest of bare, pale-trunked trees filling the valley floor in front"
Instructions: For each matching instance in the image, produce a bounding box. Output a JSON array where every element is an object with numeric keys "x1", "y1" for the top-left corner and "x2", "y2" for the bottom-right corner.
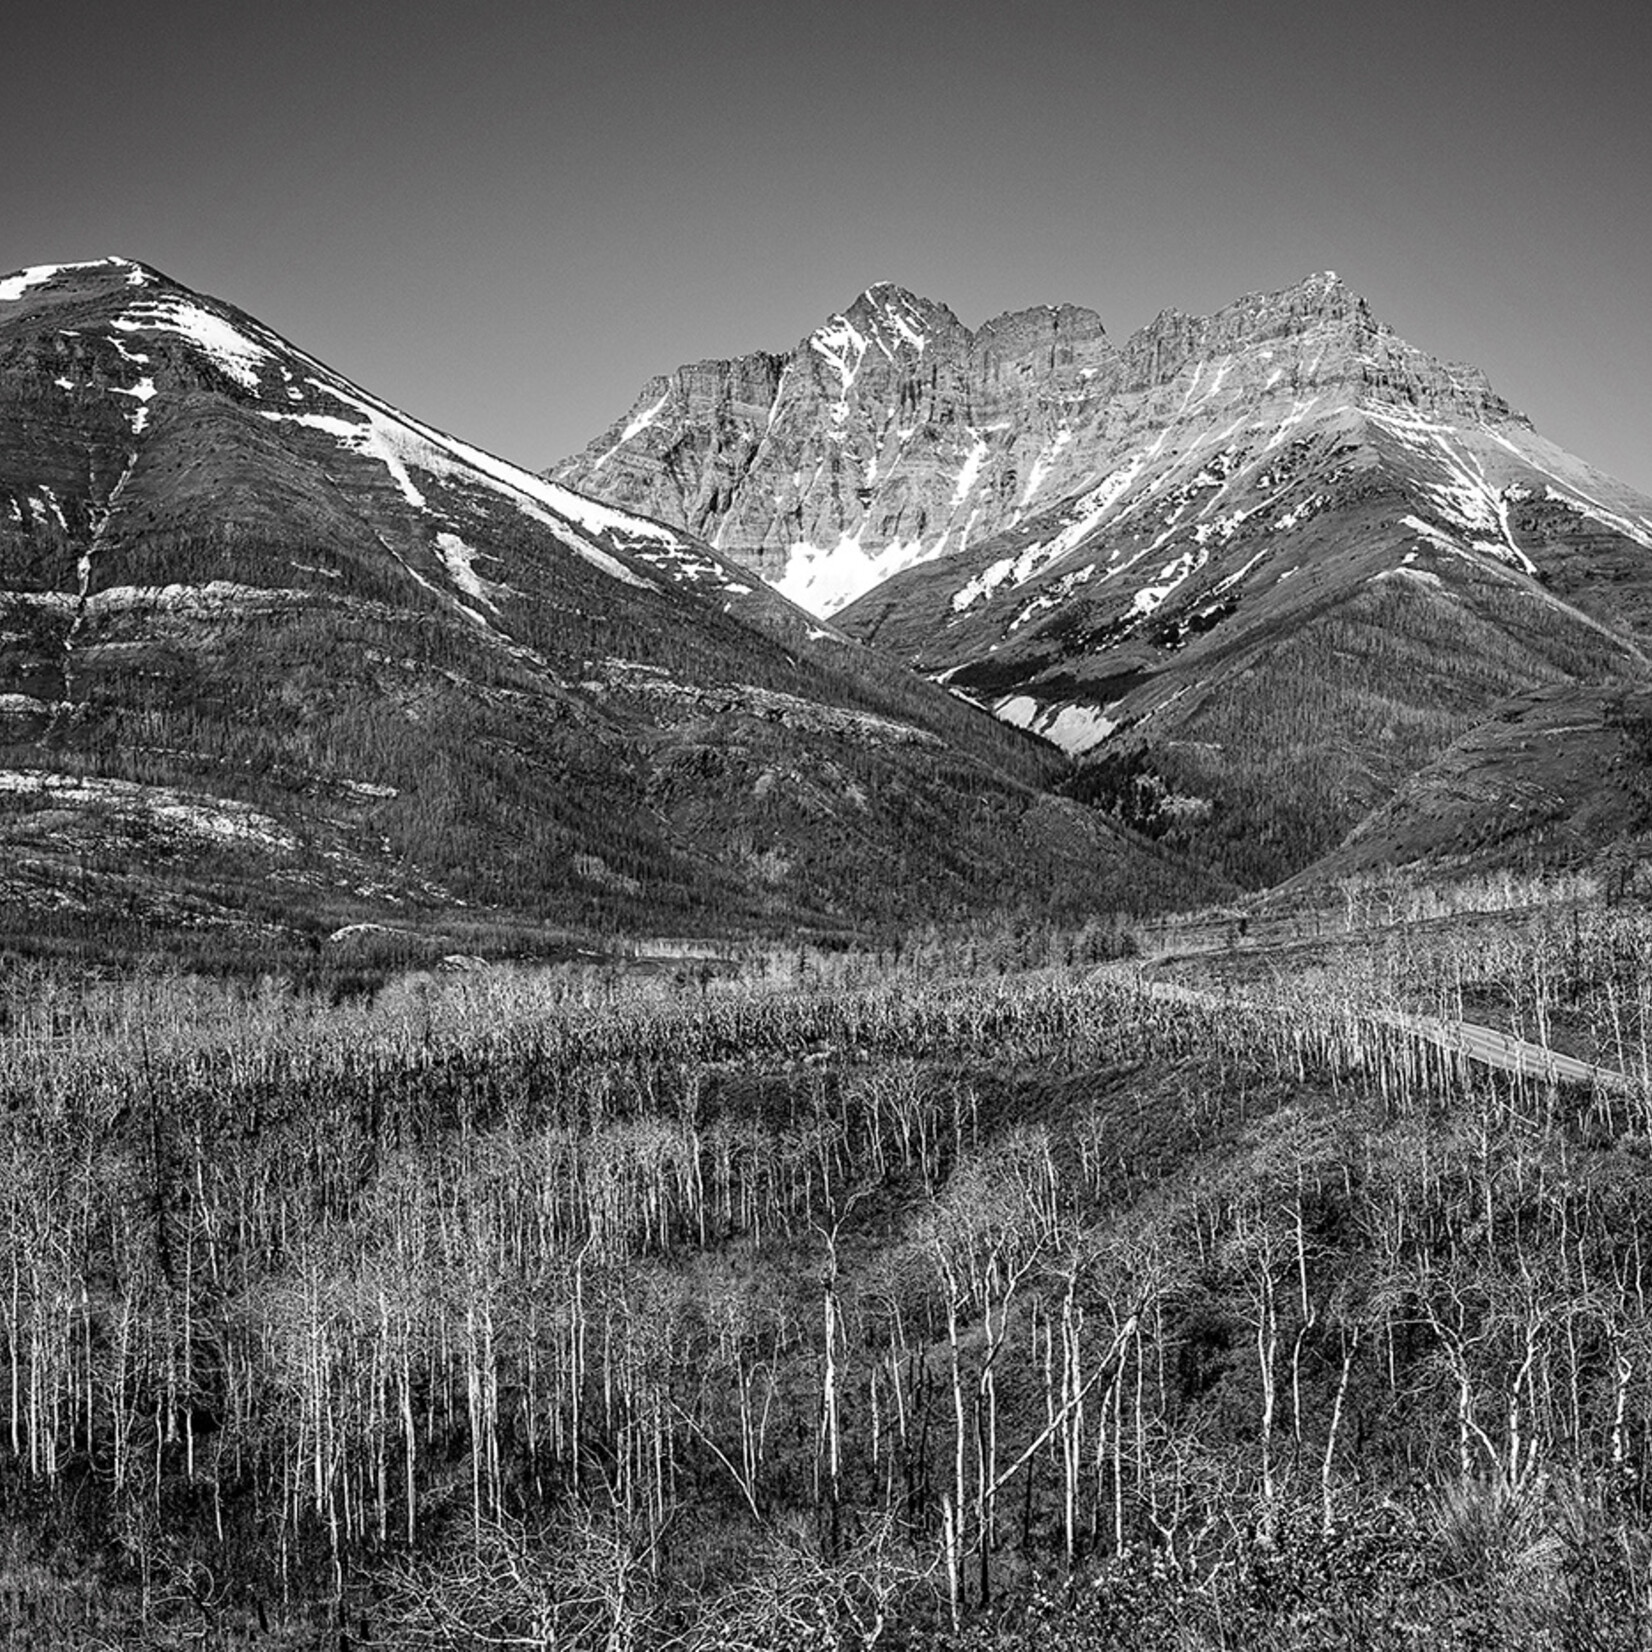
[{"x1": 0, "y1": 900, "x2": 1652, "y2": 1652}]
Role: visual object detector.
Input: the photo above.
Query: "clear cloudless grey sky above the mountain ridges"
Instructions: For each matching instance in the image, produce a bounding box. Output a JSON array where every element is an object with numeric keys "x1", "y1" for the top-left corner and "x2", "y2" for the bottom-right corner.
[{"x1": 12, "y1": 0, "x2": 1652, "y2": 492}]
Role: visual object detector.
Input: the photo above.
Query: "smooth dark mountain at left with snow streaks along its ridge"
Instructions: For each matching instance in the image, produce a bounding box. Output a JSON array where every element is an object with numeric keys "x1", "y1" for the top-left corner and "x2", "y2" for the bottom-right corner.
[{"x1": 0, "y1": 258, "x2": 1202, "y2": 950}]
